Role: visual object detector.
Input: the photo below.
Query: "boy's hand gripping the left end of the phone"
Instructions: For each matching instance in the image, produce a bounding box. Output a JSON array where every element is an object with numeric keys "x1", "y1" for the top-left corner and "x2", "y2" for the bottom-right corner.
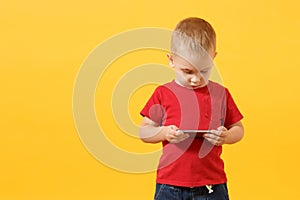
[{"x1": 164, "y1": 125, "x2": 189, "y2": 143}]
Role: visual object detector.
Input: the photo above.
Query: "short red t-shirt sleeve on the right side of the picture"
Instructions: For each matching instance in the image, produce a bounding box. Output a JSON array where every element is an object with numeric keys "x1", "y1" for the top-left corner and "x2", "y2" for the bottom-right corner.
[{"x1": 224, "y1": 89, "x2": 243, "y2": 127}]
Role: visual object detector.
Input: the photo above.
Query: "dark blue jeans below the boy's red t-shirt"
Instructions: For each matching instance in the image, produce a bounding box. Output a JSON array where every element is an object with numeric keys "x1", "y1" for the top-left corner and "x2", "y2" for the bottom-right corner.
[{"x1": 154, "y1": 183, "x2": 229, "y2": 200}]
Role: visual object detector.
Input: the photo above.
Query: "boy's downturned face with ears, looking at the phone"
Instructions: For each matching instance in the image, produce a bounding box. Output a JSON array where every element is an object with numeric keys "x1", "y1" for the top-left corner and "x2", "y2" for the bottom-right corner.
[{"x1": 168, "y1": 50, "x2": 215, "y2": 89}]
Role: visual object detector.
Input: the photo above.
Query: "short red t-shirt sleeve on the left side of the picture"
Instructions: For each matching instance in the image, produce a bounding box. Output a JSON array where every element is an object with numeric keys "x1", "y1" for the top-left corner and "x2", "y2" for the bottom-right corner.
[{"x1": 140, "y1": 87, "x2": 165, "y2": 125}]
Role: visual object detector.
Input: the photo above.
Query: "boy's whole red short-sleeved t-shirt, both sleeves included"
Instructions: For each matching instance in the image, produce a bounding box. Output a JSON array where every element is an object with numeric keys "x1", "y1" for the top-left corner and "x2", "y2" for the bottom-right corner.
[{"x1": 141, "y1": 81, "x2": 243, "y2": 187}]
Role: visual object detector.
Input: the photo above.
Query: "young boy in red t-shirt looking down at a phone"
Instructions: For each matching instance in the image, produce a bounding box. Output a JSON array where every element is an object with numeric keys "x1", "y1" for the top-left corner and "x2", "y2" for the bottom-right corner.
[{"x1": 140, "y1": 18, "x2": 244, "y2": 200}]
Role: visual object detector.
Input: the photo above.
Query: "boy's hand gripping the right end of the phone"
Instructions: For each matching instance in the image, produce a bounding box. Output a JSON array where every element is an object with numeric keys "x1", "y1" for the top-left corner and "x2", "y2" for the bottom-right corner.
[{"x1": 203, "y1": 126, "x2": 229, "y2": 146}]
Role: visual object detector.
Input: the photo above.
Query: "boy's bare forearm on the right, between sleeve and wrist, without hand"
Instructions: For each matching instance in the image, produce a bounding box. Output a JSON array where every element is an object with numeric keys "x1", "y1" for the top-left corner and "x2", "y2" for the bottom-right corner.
[{"x1": 224, "y1": 122, "x2": 244, "y2": 144}]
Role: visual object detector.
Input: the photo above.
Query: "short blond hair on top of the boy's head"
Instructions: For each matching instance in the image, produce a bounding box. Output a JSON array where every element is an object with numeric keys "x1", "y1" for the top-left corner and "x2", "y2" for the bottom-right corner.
[{"x1": 171, "y1": 17, "x2": 216, "y2": 55}]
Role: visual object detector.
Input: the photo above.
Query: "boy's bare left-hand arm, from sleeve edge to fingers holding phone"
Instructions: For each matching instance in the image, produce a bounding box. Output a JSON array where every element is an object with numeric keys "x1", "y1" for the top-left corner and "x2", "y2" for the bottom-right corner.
[{"x1": 139, "y1": 117, "x2": 189, "y2": 143}]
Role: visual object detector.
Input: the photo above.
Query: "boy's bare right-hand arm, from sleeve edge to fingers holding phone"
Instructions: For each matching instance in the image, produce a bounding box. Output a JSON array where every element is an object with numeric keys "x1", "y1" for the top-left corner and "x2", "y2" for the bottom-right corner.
[{"x1": 203, "y1": 121, "x2": 244, "y2": 146}]
